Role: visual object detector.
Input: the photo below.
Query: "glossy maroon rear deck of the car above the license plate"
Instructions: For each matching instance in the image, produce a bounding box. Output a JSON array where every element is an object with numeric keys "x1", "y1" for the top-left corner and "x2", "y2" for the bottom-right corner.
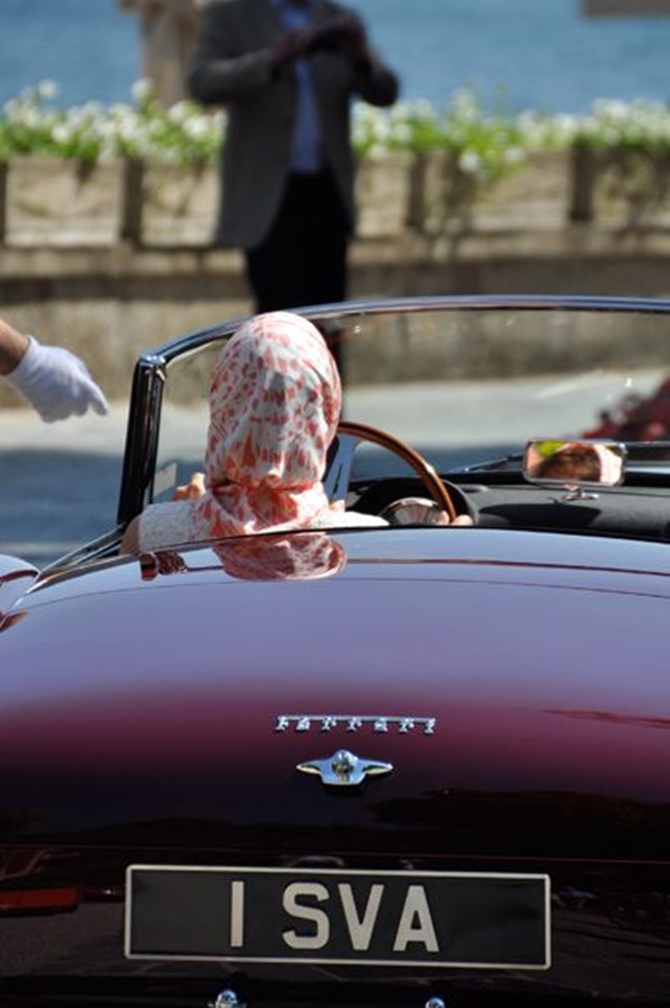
[{"x1": 0, "y1": 529, "x2": 670, "y2": 859}]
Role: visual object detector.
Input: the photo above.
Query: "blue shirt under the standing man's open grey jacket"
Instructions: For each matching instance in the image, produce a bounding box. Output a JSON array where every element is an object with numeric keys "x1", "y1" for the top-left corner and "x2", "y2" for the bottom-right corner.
[{"x1": 272, "y1": 0, "x2": 323, "y2": 173}]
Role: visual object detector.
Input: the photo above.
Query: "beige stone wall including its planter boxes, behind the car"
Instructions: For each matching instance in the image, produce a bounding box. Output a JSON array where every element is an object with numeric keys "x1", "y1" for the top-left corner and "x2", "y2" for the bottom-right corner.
[{"x1": 0, "y1": 152, "x2": 670, "y2": 406}]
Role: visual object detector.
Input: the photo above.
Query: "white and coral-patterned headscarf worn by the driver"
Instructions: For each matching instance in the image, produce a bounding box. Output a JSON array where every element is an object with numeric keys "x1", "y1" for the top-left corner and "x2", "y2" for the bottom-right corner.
[{"x1": 191, "y1": 311, "x2": 342, "y2": 539}]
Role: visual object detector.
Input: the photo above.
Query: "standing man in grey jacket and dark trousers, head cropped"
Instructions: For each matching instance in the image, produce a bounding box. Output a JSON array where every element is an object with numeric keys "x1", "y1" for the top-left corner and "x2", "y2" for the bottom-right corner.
[{"x1": 189, "y1": 0, "x2": 398, "y2": 322}]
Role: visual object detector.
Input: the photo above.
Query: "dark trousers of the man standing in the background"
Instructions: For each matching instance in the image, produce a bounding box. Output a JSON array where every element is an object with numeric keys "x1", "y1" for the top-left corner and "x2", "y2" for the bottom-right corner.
[{"x1": 246, "y1": 170, "x2": 350, "y2": 311}]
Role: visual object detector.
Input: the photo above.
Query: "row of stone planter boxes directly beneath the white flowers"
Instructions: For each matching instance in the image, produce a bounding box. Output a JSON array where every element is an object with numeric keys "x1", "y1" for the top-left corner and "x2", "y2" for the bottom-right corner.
[{"x1": 0, "y1": 150, "x2": 670, "y2": 248}]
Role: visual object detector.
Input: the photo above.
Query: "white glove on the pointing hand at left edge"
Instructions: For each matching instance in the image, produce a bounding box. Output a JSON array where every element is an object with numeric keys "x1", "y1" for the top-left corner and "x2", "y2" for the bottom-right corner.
[{"x1": 5, "y1": 336, "x2": 109, "y2": 423}]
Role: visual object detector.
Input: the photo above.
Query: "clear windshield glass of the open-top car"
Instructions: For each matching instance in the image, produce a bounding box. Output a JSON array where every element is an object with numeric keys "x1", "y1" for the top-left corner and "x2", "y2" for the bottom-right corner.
[{"x1": 154, "y1": 303, "x2": 670, "y2": 499}]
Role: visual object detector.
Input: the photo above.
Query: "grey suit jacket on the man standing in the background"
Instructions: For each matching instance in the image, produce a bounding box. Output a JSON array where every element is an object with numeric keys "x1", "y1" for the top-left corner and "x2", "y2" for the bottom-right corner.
[{"x1": 188, "y1": 0, "x2": 398, "y2": 249}]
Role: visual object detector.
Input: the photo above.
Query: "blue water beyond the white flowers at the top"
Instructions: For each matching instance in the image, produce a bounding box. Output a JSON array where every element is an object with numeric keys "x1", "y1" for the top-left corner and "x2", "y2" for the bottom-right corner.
[{"x1": 0, "y1": 0, "x2": 670, "y2": 113}]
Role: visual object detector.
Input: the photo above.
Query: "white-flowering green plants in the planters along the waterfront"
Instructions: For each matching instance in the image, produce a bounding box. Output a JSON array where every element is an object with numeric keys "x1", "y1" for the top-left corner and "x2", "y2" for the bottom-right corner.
[{"x1": 0, "y1": 82, "x2": 670, "y2": 182}]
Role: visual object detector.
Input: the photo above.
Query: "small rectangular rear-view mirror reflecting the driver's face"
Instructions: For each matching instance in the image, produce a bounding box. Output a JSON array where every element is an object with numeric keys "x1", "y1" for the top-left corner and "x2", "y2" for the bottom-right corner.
[{"x1": 523, "y1": 437, "x2": 627, "y2": 499}]
